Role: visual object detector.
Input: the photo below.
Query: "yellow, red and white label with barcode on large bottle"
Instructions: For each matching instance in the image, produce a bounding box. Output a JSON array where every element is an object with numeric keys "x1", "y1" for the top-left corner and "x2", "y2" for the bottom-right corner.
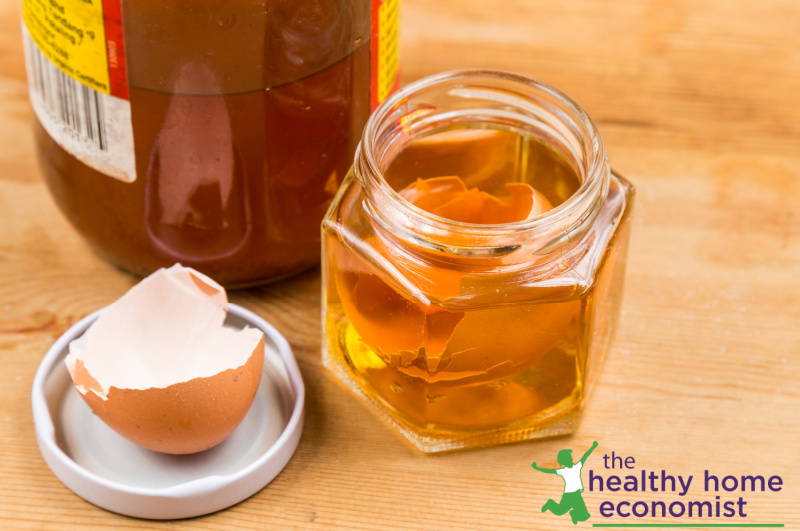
[{"x1": 21, "y1": 0, "x2": 136, "y2": 182}]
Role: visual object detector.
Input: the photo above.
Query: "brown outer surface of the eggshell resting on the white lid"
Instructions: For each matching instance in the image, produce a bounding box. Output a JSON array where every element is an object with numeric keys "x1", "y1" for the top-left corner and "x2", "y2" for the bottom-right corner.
[{"x1": 74, "y1": 337, "x2": 264, "y2": 454}]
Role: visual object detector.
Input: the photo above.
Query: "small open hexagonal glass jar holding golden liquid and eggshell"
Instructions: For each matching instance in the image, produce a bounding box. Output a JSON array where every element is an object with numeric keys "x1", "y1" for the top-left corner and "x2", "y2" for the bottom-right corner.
[{"x1": 323, "y1": 70, "x2": 634, "y2": 452}]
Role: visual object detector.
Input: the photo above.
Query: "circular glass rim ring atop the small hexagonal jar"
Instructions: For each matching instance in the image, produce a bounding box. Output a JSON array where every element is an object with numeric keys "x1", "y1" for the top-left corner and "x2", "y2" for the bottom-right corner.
[{"x1": 355, "y1": 69, "x2": 609, "y2": 241}]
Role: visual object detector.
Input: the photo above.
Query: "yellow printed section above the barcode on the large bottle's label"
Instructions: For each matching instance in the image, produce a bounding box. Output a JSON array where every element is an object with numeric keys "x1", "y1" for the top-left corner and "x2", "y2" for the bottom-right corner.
[{"x1": 22, "y1": 0, "x2": 111, "y2": 94}]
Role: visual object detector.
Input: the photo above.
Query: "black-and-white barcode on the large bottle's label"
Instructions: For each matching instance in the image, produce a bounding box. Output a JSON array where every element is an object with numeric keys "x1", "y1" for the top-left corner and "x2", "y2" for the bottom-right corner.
[{"x1": 25, "y1": 30, "x2": 108, "y2": 151}]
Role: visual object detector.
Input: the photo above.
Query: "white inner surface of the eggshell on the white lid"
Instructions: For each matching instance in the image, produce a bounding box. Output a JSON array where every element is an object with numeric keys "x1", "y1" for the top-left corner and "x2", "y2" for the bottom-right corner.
[{"x1": 65, "y1": 264, "x2": 263, "y2": 400}]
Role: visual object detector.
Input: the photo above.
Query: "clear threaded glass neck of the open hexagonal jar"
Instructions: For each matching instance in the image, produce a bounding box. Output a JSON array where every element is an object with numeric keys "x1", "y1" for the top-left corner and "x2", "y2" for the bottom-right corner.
[{"x1": 356, "y1": 69, "x2": 608, "y2": 237}]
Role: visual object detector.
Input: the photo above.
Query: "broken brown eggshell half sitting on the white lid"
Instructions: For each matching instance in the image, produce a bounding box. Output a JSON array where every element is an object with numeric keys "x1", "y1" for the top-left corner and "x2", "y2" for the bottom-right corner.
[{"x1": 65, "y1": 265, "x2": 264, "y2": 454}]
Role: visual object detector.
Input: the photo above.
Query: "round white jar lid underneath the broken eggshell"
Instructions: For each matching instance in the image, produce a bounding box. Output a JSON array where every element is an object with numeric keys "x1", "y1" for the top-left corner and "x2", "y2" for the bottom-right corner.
[{"x1": 32, "y1": 304, "x2": 305, "y2": 519}]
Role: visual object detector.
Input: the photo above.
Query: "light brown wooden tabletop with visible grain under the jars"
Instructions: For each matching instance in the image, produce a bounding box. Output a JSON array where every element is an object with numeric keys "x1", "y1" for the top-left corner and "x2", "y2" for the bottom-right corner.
[{"x1": 0, "y1": 0, "x2": 800, "y2": 529}]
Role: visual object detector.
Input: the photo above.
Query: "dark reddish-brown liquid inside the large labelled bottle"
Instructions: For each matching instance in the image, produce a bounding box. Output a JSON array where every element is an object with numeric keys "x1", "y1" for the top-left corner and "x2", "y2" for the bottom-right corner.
[{"x1": 36, "y1": 0, "x2": 370, "y2": 285}]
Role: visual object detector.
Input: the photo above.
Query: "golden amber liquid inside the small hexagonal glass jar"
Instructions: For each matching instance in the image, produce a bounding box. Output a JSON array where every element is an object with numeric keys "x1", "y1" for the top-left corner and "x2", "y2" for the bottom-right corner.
[{"x1": 324, "y1": 129, "x2": 626, "y2": 445}]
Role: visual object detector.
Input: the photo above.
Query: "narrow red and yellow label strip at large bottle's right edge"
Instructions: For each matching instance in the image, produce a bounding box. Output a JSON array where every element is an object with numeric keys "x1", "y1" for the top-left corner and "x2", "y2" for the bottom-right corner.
[{"x1": 370, "y1": 0, "x2": 400, "y2": 110}]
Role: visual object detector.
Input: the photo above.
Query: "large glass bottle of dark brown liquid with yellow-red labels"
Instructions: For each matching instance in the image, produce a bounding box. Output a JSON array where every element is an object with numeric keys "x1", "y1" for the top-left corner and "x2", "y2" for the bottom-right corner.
[{"x1": 22, "y1": 0, "x2": 399, "y2": 286}]
